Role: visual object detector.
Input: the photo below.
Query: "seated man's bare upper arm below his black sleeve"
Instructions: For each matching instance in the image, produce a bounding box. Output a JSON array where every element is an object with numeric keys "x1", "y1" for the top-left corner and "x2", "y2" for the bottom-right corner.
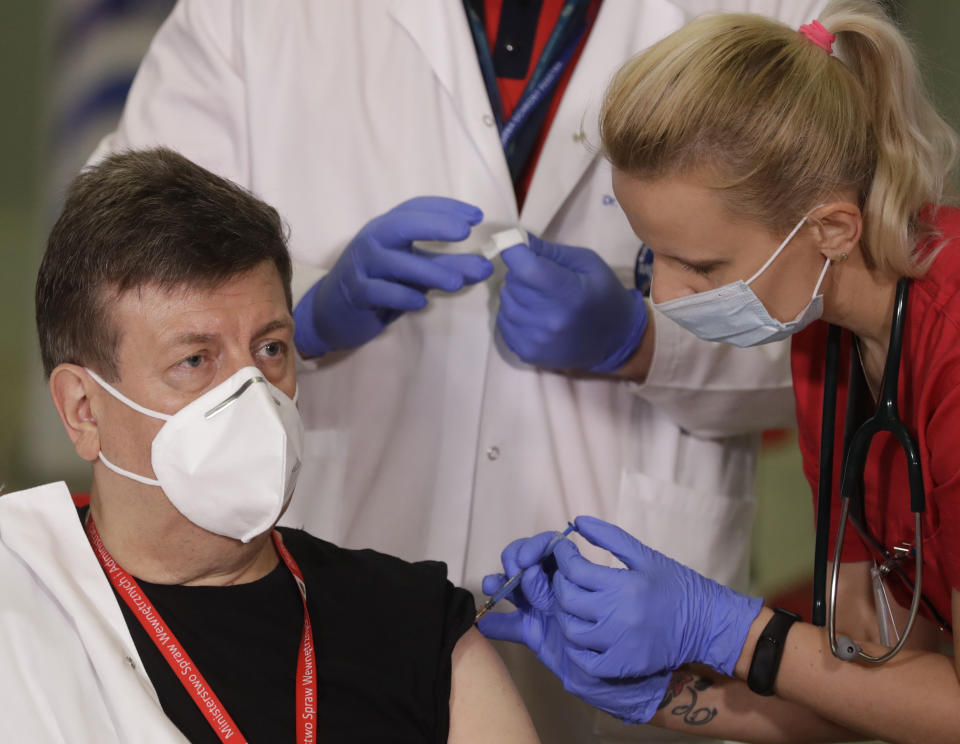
[{"x1": 447, "y1": 628, "x2": 539, "y2": 744}]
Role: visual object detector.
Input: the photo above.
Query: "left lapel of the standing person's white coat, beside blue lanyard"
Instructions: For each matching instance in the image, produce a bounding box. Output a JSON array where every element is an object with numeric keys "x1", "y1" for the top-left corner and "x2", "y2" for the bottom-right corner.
[{"x1": 389, "y1": 0, "x2": 517, "y2": 214}]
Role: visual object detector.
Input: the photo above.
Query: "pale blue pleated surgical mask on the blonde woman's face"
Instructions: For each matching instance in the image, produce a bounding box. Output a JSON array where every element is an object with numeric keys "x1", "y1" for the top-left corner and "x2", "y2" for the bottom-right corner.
[{"x1": 653, "y1": 216, "x2": 830, "y2": 347}]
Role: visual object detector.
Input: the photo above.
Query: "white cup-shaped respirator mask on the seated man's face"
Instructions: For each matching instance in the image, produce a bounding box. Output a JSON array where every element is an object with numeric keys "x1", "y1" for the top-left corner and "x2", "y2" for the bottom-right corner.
[{"x1": 87, "y1": 367, "x2": 303, "y2": 542}]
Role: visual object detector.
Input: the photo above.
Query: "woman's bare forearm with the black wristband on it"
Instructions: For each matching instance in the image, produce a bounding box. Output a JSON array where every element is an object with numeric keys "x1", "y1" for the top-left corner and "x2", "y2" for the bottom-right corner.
[{"x1": 735, "y1": 608, "x2": 960, "y2": 744}]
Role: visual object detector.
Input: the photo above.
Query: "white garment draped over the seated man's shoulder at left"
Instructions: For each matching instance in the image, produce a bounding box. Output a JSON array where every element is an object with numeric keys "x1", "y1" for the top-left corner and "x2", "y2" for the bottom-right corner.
[{"x1": 0, "y1": 482, "x2": 187, "y2": 744}]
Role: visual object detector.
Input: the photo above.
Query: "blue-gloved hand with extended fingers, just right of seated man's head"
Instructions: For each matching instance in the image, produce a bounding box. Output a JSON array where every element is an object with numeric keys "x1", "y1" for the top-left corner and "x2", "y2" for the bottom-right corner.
[{"x1": 293, "y1": 196, "x2": 493, "y2": 356}]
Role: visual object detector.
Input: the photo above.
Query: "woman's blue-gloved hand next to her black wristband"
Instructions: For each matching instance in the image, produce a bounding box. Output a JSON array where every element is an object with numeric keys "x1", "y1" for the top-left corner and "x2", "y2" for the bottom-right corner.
[{"x1": 553, "y1": 517, "x2": 763, "y2": 677}]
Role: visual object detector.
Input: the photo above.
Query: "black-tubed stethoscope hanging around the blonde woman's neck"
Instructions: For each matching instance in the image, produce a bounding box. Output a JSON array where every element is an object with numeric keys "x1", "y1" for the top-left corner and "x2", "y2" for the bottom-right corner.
[{"x1": 813, "y1": 277, "x2": 950, "y2": 664}]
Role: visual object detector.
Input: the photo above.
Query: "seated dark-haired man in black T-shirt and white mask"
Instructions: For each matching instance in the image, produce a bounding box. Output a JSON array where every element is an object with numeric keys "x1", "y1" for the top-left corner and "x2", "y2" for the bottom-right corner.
[{"x1": 0, "y1": 149, "x2": 536, "y2": 744}]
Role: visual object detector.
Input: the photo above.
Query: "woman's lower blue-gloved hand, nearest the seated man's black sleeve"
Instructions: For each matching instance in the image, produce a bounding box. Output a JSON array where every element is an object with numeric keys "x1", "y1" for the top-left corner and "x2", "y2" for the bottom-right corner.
[{"x1": 478, "y1": 532, "x2": 671, "y2": 723}]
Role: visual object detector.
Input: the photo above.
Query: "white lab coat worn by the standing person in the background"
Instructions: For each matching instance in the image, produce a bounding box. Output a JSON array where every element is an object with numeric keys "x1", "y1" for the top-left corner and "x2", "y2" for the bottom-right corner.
[{"x1": 93, "y1": 0, "x2": 823, "y2": 742}]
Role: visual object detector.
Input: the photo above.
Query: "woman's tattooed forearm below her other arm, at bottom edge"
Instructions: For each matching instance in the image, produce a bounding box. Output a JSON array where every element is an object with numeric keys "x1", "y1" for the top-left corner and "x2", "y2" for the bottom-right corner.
[{"x1": 650, "y1": 665, "x2": 862, "y2": 744}]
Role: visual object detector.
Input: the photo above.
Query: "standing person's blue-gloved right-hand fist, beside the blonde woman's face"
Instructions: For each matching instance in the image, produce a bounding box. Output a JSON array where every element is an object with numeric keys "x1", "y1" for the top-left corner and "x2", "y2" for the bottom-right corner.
[{"x1": 497, "y1": 235, "x2": 647, "y2": 372}]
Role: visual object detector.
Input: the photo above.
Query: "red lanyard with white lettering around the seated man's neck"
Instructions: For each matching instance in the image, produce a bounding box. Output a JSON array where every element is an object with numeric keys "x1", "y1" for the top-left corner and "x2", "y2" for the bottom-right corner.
[{"x1": 86, "y1": 517, "x2": 317, "y2": 744}]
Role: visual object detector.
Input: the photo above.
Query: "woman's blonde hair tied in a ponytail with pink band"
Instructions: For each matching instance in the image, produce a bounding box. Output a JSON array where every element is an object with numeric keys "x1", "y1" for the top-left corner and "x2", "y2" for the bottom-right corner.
[{"x1": 600, "y1": 0, "x2": 957, "y2": 276}]
